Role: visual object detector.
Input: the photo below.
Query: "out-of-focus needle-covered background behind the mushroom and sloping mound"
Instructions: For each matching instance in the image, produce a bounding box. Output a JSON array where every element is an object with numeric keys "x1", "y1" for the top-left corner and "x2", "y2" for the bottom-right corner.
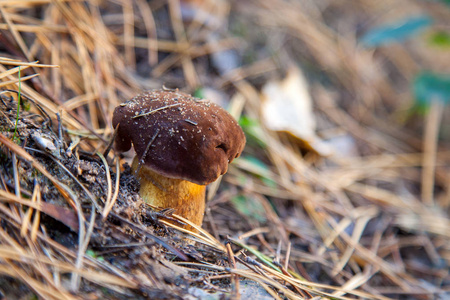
[{"x1": 0, "y1": 0, "x2": 450, "y2": 299}]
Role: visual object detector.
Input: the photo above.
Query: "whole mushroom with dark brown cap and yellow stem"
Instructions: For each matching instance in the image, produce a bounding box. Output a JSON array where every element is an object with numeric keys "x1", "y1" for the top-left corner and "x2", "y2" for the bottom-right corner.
[{"x1": 113, "y1": 90, "x2": 245, "y2": 226}]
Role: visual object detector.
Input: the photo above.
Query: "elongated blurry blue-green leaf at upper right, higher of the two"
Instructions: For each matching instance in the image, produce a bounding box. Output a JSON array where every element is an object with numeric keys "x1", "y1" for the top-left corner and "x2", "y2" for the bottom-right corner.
[{"x1": 361, "y1": 16, "x2": 432, "y2": 47}]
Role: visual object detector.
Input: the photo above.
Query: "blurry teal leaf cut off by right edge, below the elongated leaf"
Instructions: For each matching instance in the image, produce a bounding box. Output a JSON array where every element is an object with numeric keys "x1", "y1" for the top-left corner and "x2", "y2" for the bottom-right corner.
[{"x1": 413, "y1": 72, "x2": 450, "y2": 108}]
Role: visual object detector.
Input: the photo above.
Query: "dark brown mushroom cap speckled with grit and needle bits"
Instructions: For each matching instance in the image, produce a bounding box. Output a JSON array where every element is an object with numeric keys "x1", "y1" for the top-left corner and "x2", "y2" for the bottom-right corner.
[{"x1": 113, "y1": 90, "x2": 245, "y2": 185}]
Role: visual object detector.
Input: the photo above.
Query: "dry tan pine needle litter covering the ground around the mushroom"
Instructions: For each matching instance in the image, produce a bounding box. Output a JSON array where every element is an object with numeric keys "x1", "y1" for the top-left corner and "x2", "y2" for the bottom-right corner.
[{"x1": 0, "y1": 0, "x2": 450, "y2": 299}]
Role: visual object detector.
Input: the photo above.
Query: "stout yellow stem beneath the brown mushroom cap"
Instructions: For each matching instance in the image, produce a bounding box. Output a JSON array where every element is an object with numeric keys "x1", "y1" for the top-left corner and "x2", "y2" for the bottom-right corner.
[{"x1": 131, "y1": 156, "x2": 206, "y2": 228}]
